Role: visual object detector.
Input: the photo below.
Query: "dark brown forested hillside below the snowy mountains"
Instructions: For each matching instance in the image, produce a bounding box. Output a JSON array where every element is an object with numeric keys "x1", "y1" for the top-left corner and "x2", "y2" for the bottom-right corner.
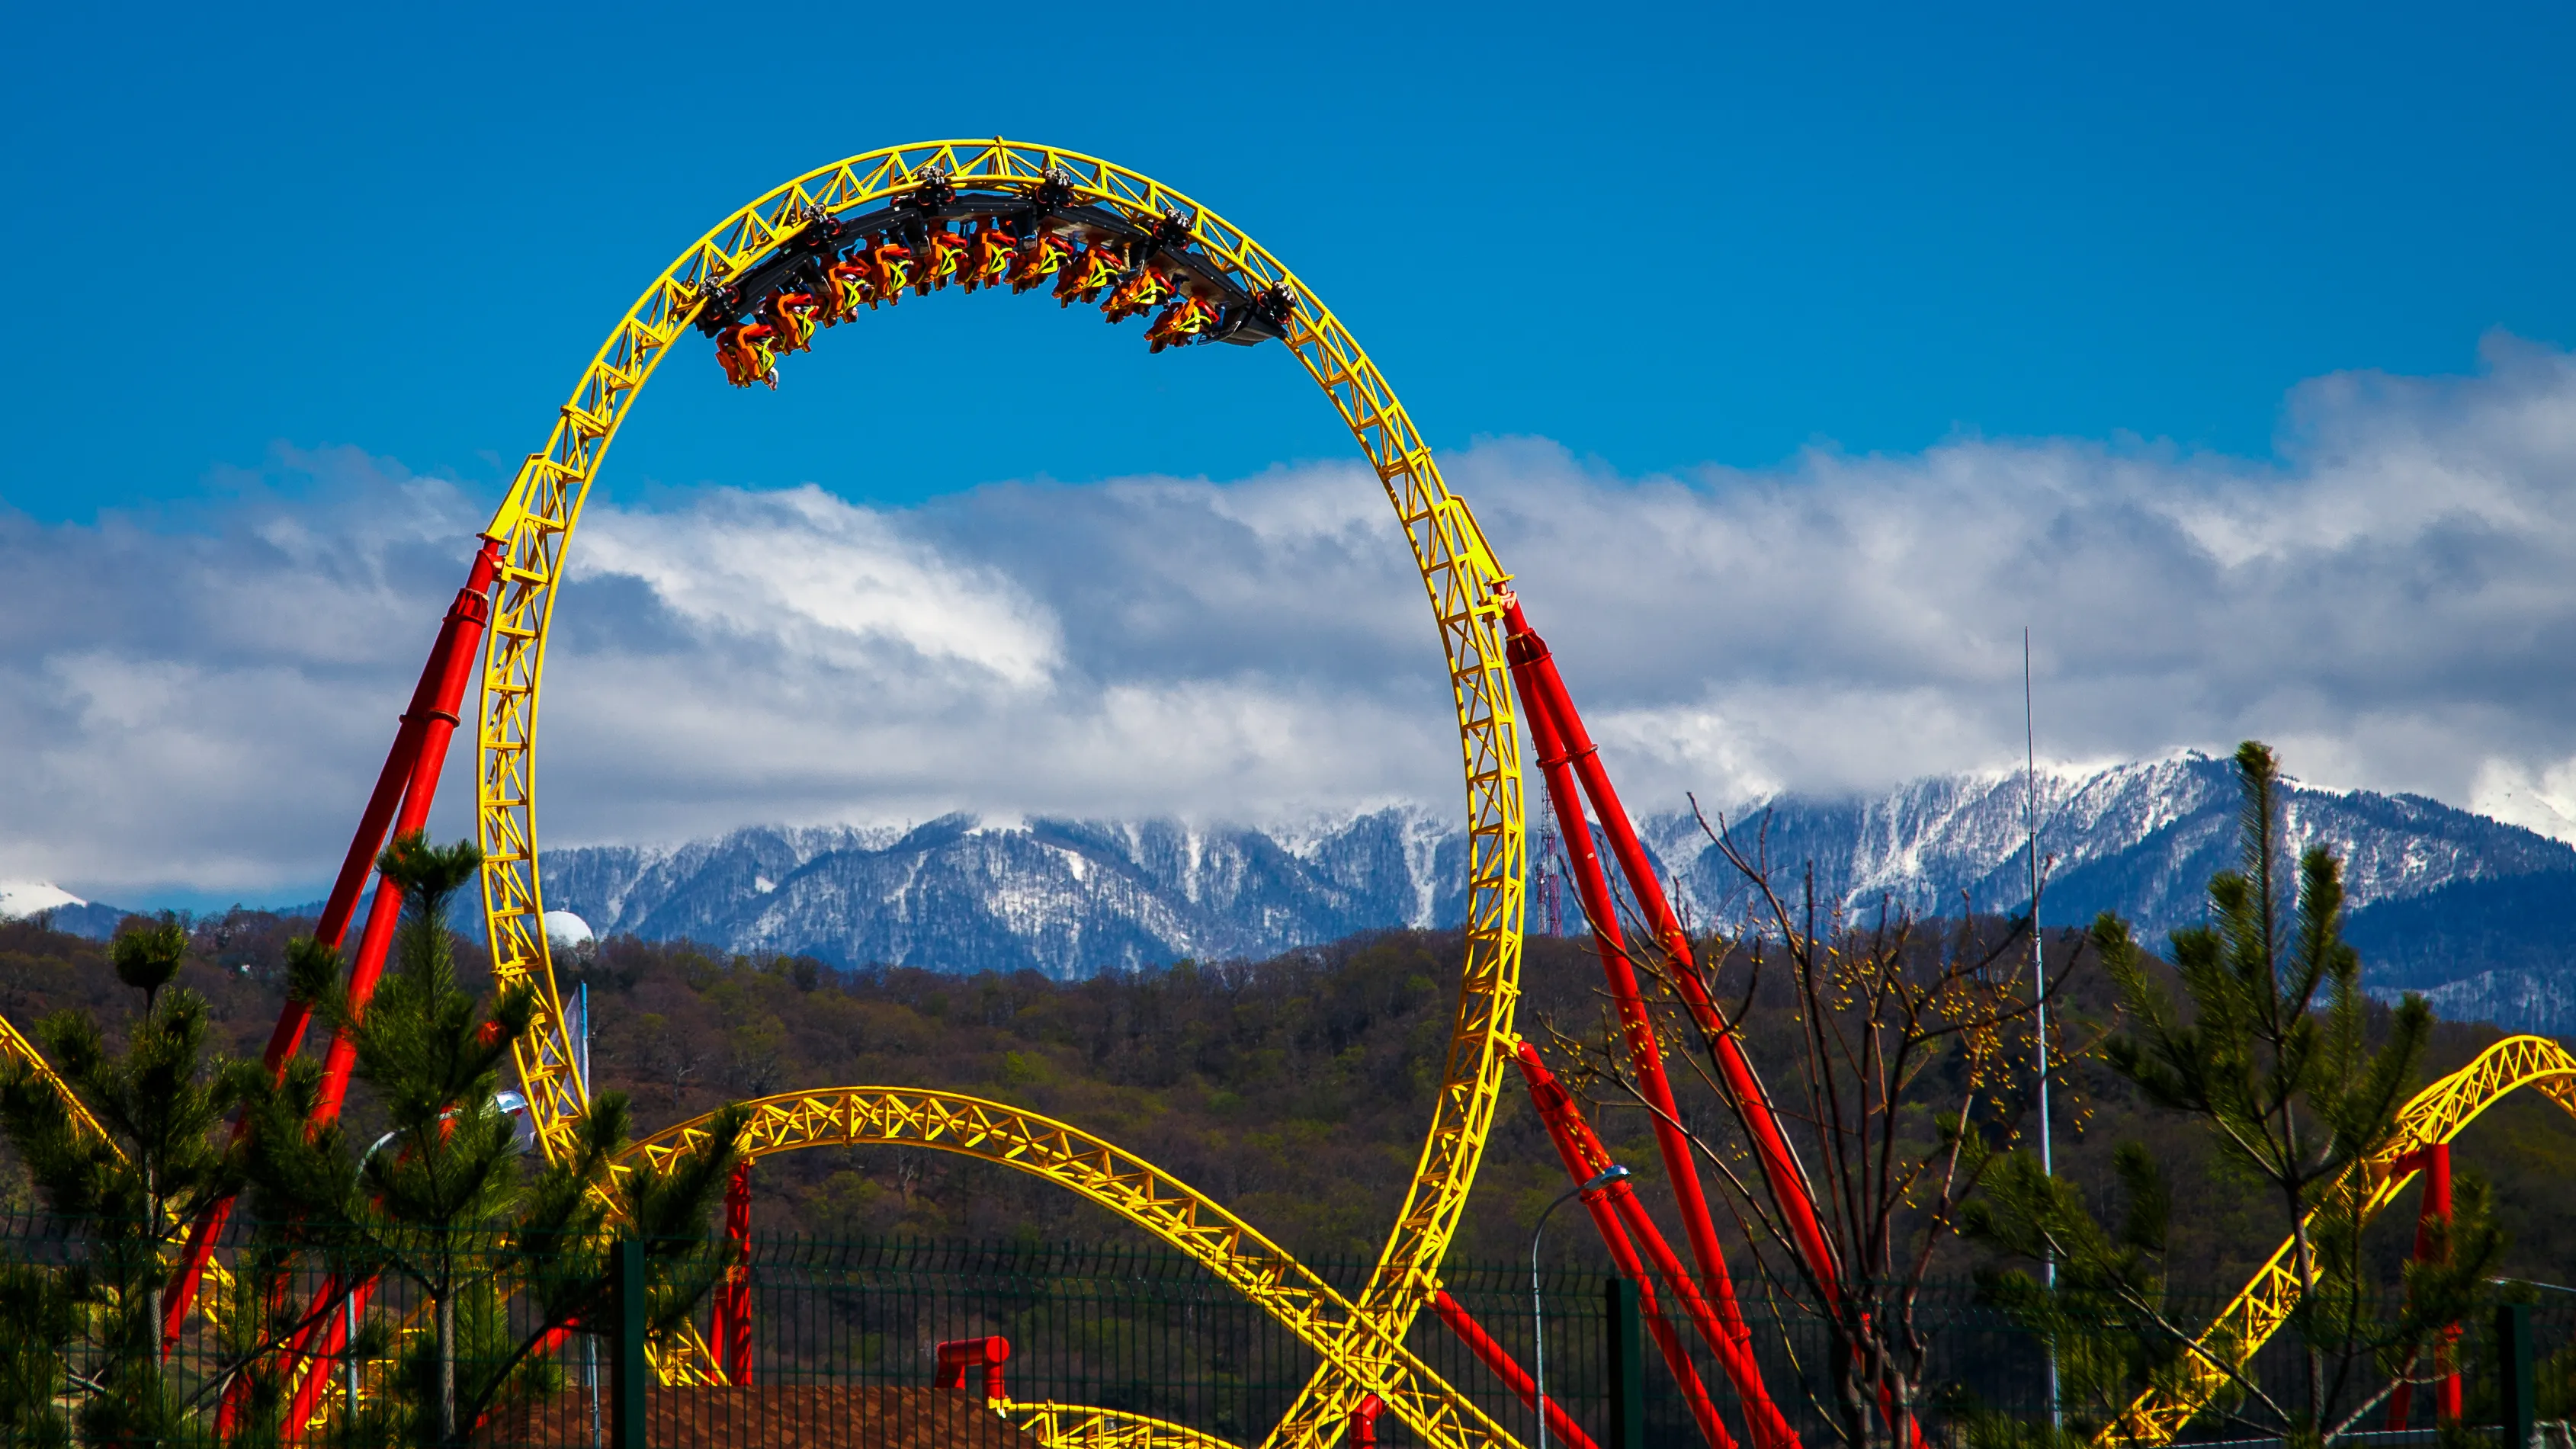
[{"x1": 0, "y1": 911, "x2": 2576, "y2": 1287}]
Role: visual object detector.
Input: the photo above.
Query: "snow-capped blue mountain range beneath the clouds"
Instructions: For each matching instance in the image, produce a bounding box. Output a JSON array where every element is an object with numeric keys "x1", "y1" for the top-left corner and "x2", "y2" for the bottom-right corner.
[{"x1": 544, "y1": 754, "x2": 2576, "y2": 1030}]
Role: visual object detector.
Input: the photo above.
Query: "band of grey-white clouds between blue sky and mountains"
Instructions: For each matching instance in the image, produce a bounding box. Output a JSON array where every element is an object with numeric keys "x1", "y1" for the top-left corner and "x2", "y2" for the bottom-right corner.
[{"x1": 0, "y1": 337, "x2": 2576, "y2": 898}]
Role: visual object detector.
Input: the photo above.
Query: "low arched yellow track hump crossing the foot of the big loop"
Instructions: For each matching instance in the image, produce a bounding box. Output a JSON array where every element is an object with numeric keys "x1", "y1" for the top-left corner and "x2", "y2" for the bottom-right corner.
[{"x1": 624, "y1": 1086, "x2": 1512, "y2": 1444}]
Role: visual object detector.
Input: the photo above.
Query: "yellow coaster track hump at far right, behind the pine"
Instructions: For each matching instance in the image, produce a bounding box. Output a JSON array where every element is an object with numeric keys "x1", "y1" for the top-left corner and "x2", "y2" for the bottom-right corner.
[{"x1": 2094, "y1": 1037, "x2": 2576, "y2": 1449}]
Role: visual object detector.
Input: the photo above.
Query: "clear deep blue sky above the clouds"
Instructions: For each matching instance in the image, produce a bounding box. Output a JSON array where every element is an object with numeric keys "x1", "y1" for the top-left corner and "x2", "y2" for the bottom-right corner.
[{"x1": 0, "y1": 5, "x2": 2576, "y2": 520}]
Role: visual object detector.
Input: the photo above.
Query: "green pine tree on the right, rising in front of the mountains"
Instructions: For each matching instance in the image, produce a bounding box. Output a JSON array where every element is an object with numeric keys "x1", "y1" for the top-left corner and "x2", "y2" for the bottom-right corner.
[{"x1": 1965, "y1": 741, "x2": 2504, "y2": 1444}]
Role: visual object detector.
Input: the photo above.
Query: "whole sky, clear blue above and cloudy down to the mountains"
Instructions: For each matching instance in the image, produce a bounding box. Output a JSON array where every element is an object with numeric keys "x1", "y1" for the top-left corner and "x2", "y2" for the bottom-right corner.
[{"x1": 0, "y1": 5, "x2": 2576, "y2": 903}]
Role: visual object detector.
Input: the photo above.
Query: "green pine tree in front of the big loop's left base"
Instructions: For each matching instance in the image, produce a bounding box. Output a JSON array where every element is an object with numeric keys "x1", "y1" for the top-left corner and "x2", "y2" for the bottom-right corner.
[{"x1": 250, "y1": 834, "x2": 742, "y2": 1447}]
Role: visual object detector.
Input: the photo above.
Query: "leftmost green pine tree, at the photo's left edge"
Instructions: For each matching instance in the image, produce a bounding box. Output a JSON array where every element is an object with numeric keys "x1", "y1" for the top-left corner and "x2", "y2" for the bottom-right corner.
[{"x1": 0, "y1": 914, "x2": 234, "y2": 1444}]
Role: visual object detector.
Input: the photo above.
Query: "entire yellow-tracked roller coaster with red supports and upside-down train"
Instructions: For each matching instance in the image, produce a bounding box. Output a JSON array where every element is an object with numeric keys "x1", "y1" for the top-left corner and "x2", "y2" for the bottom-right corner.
[{"x1": 0, "y1": 139, "x2": 2576, "y2": 1449}]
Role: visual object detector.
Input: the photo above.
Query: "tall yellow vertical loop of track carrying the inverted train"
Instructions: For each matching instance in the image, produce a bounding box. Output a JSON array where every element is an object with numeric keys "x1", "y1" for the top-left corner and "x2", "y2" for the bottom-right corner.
[{"x1": 474, "y1": 139, "x2": 1525, "y2": 1447}]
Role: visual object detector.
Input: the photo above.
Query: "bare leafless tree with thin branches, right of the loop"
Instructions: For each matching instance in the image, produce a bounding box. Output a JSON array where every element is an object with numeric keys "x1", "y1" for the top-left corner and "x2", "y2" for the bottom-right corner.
[{"x1": 1548, "y1": 803, "x2": 2084, "y2": 1449}]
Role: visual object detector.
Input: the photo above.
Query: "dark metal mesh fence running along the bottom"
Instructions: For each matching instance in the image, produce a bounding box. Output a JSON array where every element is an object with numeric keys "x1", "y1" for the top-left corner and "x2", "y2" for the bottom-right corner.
[{"x1": 0, "y1": 1220, "x2": 2576, "y2": 1449}]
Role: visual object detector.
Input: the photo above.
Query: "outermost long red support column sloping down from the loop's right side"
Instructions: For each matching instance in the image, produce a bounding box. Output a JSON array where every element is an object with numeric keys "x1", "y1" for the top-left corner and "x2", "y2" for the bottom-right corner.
[{"x1": 1500, "y1": 589, "x2": 1840, "y2": 1305}]
